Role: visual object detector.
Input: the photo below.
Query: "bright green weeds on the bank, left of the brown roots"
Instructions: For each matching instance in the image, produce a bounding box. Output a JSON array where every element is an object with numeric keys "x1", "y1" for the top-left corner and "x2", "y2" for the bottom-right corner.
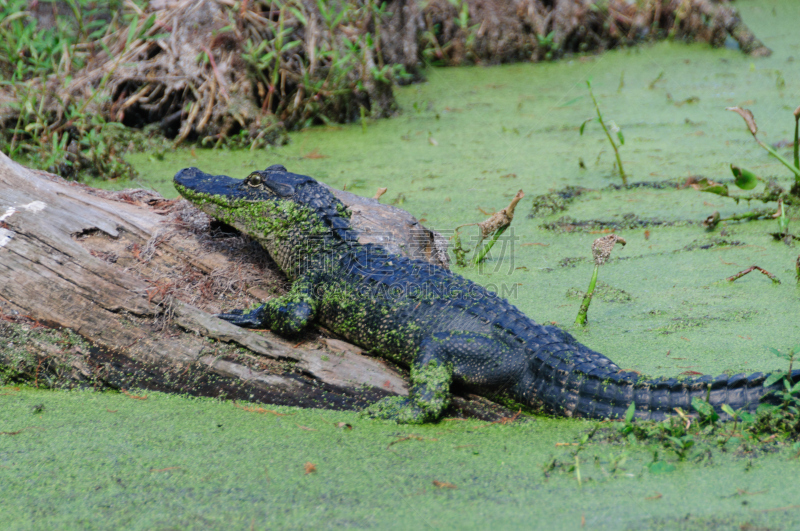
[{"x1": 0, "y1": 0, "x2": 158, "y2": 179}]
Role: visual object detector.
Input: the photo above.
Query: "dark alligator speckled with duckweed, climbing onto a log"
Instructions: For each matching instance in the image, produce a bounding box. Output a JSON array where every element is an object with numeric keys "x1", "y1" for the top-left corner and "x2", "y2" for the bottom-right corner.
[{"x1": 174, "y1": 165, "x2": 800, "y2": 423}]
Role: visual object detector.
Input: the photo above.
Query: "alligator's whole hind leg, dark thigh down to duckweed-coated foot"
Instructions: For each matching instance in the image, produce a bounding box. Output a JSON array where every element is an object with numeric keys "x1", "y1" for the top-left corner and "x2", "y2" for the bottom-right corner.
[{"x1": 364, "y1": 332, "x2": 510, "y2": 424}]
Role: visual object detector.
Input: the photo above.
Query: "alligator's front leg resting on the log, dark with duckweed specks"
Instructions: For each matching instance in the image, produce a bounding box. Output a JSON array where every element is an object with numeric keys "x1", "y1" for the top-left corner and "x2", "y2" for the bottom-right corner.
[{"x1": 217, "y1": 278, "x2": 317, "y2": 336}]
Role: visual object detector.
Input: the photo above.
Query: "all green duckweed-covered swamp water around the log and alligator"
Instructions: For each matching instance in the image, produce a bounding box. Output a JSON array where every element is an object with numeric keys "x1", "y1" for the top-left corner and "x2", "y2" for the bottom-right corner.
[{"x1": 6, "y1": 0, "x2": 800, "y2": 529}]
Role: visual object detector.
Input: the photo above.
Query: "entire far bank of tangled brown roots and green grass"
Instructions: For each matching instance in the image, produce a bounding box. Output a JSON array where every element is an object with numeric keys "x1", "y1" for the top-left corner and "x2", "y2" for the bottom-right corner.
[{"x1": 0, "y1": 0, "x2": 770, "y2": 179}]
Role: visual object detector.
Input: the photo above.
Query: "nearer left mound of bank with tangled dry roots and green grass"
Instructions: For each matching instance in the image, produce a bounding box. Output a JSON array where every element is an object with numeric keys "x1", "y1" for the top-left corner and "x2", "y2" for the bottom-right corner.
[{"x1": 0, "y1": 0, "x2": 406, "y2": 179}]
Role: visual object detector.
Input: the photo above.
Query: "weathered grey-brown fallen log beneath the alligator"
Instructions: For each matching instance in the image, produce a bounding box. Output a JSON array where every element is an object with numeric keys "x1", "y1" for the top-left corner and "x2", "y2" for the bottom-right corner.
[{"x1": 0, "y1": 153, "x2": 507, "y2": 418}]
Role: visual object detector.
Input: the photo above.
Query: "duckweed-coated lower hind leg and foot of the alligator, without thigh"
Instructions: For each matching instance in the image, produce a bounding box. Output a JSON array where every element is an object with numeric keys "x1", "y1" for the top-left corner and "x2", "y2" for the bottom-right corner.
[{"x1": 364, "y1": 337, "x2": 456, "y2": 424}]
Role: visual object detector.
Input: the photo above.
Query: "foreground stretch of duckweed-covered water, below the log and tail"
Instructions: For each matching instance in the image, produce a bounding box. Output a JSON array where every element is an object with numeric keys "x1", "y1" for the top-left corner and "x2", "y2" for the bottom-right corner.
[{"x1": 0, "y1": 387, "x2": 800, "y2": 530}]
